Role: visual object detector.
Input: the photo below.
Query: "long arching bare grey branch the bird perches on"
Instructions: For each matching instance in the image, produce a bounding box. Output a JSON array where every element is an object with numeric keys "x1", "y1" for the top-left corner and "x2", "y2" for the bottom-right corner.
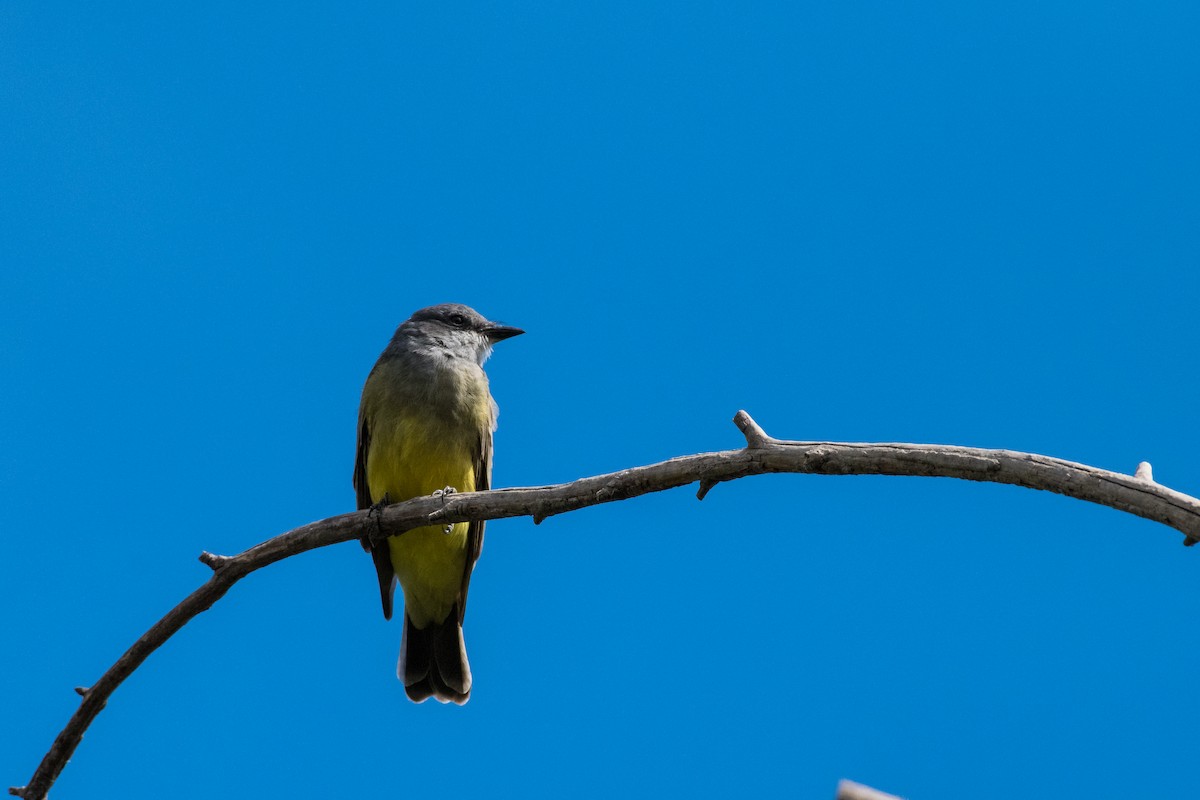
[{"x1": 8, "y1": 411, "x2": 1200, "y2": 800}]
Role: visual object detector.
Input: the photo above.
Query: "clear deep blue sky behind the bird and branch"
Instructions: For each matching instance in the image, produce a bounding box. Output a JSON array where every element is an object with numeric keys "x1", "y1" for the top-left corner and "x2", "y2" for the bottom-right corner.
[{"x1": 0, "y1": 1, "x2": 1200, "y2": 800}]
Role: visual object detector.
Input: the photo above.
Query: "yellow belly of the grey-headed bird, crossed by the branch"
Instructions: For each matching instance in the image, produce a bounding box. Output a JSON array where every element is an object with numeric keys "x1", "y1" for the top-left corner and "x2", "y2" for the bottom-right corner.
[{"x1": 367, "y1": 416, "x2": 478, "y2": 628}]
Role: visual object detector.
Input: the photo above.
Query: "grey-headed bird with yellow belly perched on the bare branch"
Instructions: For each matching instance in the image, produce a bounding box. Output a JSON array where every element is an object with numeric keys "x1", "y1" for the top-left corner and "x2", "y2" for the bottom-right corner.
[{"x1": 354, "y1": 303, "x2": 524, "y2": 705}]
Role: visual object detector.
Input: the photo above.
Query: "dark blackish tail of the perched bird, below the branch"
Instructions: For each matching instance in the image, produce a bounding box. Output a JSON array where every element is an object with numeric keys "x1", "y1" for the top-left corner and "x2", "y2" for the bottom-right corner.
[{"x1": 396, "y1": 606, "x2": 470, "y2": 705}]
